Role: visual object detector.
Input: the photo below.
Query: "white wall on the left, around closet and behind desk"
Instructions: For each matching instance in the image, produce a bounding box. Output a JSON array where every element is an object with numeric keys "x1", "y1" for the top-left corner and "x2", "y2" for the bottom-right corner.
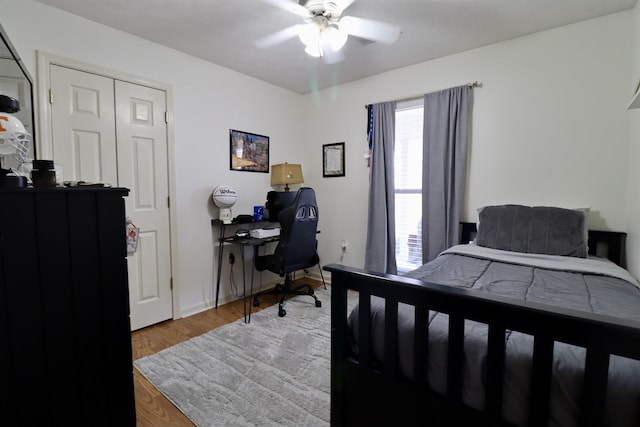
[{"x1": 0, "y1": 0, "x2": 305, "y2": 315}]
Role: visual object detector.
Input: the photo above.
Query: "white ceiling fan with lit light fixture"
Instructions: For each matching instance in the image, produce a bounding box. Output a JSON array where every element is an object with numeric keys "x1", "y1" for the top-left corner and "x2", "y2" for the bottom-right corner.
[{"x1": 256, "y1": 0, "x2": 401, "y2": 63}]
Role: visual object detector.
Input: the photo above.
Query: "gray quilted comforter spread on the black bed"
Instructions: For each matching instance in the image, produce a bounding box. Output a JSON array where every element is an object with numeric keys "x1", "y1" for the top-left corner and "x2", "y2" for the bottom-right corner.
[{"x1": 349, "y1": 245, "x2": 640, "y2": 427}]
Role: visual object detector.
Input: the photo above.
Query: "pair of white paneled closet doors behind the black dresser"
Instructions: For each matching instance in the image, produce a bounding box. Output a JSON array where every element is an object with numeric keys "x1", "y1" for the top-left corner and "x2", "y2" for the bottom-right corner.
[{"x1": 50, "y1": 65, "x2": 173, "y2": 330}]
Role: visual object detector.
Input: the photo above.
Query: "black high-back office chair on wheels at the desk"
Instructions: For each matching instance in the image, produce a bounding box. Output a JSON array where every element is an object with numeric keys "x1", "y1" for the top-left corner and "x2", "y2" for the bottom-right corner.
[{"x1": 253, "y1": 187, "x2": 327, "y2": 317}]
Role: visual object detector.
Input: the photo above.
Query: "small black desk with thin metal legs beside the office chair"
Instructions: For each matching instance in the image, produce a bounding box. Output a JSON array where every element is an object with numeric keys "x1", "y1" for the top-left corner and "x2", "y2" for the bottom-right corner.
[{"x1": 211, "y1": 219, "x2": 279, "y2": 322}]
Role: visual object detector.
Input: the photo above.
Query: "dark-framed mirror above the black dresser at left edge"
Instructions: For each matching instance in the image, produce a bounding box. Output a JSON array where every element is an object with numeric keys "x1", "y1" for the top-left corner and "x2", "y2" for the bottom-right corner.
[{"x1": 0, "y1": 25, "x2": 37, "y2": 166}]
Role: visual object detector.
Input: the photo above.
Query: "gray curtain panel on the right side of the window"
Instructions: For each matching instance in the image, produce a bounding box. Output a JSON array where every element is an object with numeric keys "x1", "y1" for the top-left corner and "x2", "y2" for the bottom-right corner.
[{"x1": 422, "y1": 85, "x2": 472, "y2": 262}]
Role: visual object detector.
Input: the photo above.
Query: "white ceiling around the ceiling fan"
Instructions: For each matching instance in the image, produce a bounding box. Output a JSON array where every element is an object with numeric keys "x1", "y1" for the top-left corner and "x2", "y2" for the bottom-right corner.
[{"x1": 38, "y1": 0, "x2": 637, "y2": 94}]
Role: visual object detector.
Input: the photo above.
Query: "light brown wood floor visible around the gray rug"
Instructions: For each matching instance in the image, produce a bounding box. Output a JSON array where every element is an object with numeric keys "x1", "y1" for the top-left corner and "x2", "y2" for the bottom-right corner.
[{"x1": 131, "y1": 279, "x2": 322, "y2": 427}]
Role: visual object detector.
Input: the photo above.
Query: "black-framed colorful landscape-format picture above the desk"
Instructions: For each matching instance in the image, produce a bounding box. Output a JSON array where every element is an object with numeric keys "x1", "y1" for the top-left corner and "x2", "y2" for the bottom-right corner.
[{"x1": 229, "y1": 129, "x2": 269, "y2": 173}]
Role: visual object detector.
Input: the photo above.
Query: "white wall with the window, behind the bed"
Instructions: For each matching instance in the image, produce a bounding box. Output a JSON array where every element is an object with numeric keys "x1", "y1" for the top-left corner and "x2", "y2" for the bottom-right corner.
[{"x1": 306, "y1": 12, "x2": 632, "y2": 274}]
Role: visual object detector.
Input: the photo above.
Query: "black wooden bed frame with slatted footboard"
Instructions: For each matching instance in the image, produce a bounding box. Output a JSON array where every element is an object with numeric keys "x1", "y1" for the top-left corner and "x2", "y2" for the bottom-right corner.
[{"x1": 324, "y1": 227, "x2": 640, "y2": 426}]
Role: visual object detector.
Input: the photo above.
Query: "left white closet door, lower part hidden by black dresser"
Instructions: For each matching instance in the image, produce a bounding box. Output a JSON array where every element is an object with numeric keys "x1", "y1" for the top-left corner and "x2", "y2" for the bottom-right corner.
[{"x1": 50, "y1": 65, "x2": 118, "y2": 186}]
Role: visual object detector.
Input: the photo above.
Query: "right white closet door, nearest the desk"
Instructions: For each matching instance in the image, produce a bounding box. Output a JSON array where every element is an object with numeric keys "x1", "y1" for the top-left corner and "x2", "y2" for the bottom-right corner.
[{"x1": 115, "y1": 80, "x2": 172, "y2": 330}]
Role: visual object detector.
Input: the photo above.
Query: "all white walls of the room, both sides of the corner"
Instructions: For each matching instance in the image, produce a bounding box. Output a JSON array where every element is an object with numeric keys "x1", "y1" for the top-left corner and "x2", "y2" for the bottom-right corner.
[{"x1": 0, "y1": 0, "x2": 640, "y2": 315}]
